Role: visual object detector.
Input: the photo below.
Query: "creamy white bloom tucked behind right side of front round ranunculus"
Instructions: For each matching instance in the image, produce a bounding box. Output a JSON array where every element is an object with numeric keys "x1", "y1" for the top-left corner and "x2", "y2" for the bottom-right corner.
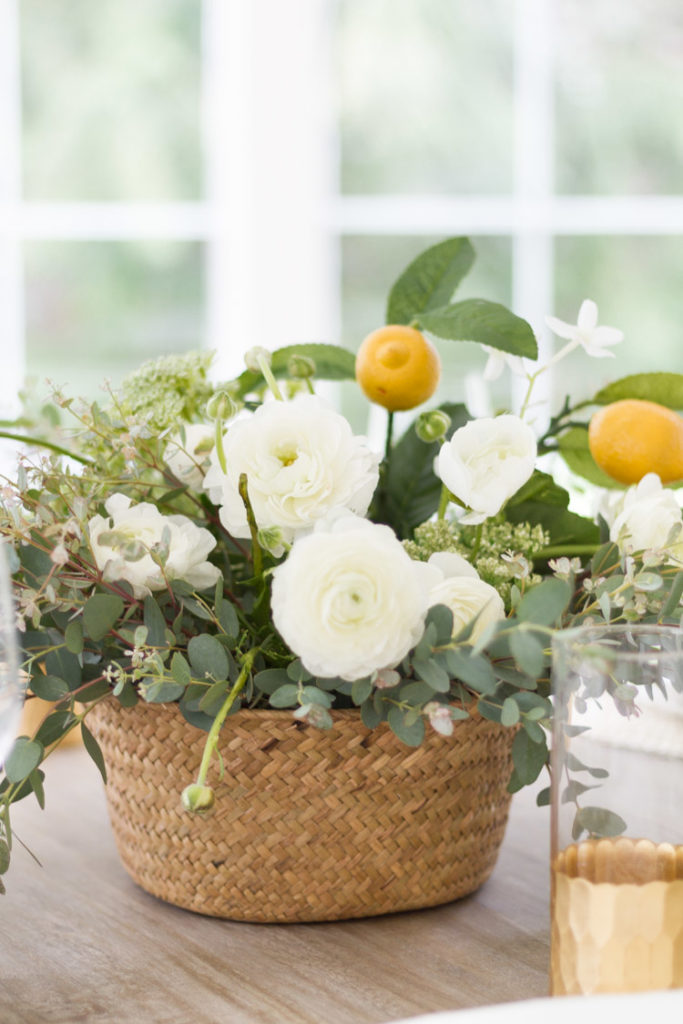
[{"x1": 428, "y1": 552, "x2": 505, "y2": 643}]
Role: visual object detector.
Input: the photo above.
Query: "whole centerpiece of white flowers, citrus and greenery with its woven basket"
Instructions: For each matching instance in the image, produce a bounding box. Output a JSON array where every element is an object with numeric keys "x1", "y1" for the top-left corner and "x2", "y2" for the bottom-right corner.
[{"x1": 0, "y1": 238, "x2": 683, "y2": 921}]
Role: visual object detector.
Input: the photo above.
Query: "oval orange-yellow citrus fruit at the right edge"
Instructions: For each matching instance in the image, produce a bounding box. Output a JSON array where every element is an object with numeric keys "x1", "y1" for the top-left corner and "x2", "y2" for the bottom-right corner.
[{"x1": 588, "y1": 398, "x2": 683, "y2": 483}]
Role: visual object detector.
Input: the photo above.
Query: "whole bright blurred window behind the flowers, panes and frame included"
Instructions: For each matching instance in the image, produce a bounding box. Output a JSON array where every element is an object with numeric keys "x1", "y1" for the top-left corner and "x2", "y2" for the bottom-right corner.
[{"x1": 0, "y1": 0, "x2": 683, "y2": 425}]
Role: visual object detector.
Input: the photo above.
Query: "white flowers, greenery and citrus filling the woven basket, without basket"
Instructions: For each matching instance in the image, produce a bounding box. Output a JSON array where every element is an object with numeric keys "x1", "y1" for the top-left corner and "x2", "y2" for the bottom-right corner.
[{"x1": 0, "y1": 239, "x2": 683, "y2": 888}]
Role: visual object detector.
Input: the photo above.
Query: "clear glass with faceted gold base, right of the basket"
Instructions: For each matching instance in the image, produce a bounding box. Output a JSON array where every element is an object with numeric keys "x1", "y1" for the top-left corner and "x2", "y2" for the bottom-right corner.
[{"x1": 551, "y1": 625, "x2": 683, "y2": 995}]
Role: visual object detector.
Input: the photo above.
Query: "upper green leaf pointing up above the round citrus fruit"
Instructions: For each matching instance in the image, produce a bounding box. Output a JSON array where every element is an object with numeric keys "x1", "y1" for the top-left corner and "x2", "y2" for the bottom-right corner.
[{"x1": 386, "y1": 238, "x2": 474, "y2": 324}]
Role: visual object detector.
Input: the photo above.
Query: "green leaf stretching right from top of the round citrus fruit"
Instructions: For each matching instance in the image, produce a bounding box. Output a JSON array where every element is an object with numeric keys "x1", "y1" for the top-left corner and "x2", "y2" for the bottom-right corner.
[{"x1": 419, "y1": 299, "x2": 539, "y2": 359}]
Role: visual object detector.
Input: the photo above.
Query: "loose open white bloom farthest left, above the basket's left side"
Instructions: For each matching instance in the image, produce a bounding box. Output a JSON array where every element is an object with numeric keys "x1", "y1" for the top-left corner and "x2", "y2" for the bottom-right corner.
[{"x1": 88, "y1": 494, "x2": 220, "y2": 597}]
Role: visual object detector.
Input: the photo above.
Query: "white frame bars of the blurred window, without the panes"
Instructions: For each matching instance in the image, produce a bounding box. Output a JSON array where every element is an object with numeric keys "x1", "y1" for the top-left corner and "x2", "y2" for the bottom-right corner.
[{"x1": 0, "y1": 0, "x2": 683, "y2": 416}]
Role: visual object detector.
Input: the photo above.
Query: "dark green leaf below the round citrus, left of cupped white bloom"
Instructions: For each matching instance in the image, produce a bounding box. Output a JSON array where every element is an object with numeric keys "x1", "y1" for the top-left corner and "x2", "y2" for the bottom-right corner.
[{"x1": 374, "y1": 402, "x2": 470, "y2": 538}]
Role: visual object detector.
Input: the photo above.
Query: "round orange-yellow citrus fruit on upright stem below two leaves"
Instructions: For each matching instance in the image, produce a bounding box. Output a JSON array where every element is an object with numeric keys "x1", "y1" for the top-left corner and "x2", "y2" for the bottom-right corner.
[{"x1": 355, "y1": 324, "x2": 441, "y2": 413}]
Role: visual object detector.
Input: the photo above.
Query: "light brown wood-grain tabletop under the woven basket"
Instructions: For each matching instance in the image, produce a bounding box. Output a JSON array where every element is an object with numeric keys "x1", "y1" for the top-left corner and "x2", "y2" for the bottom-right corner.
[{"x1": 0, "y1": 750, "x2": 549, "y2": 1024}]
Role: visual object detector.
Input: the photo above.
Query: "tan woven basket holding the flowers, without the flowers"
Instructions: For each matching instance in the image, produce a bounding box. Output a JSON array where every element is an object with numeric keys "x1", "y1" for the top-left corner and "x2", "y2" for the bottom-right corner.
[{"x1": 88, "y1": 700, "x2": 513, "y2": 922}]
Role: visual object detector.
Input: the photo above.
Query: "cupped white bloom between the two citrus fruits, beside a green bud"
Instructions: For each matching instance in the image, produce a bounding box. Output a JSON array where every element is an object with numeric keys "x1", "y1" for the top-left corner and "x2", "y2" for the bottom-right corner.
[{"x1": 434, "y1": 414, "x2": 537, "y2": 523}]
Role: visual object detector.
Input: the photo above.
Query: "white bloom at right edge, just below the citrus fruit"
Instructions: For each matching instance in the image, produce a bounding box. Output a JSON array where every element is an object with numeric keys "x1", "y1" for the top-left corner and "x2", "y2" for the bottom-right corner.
[{"x1": 609, "y1": 473, "x2": 683, "y2": 564}]
